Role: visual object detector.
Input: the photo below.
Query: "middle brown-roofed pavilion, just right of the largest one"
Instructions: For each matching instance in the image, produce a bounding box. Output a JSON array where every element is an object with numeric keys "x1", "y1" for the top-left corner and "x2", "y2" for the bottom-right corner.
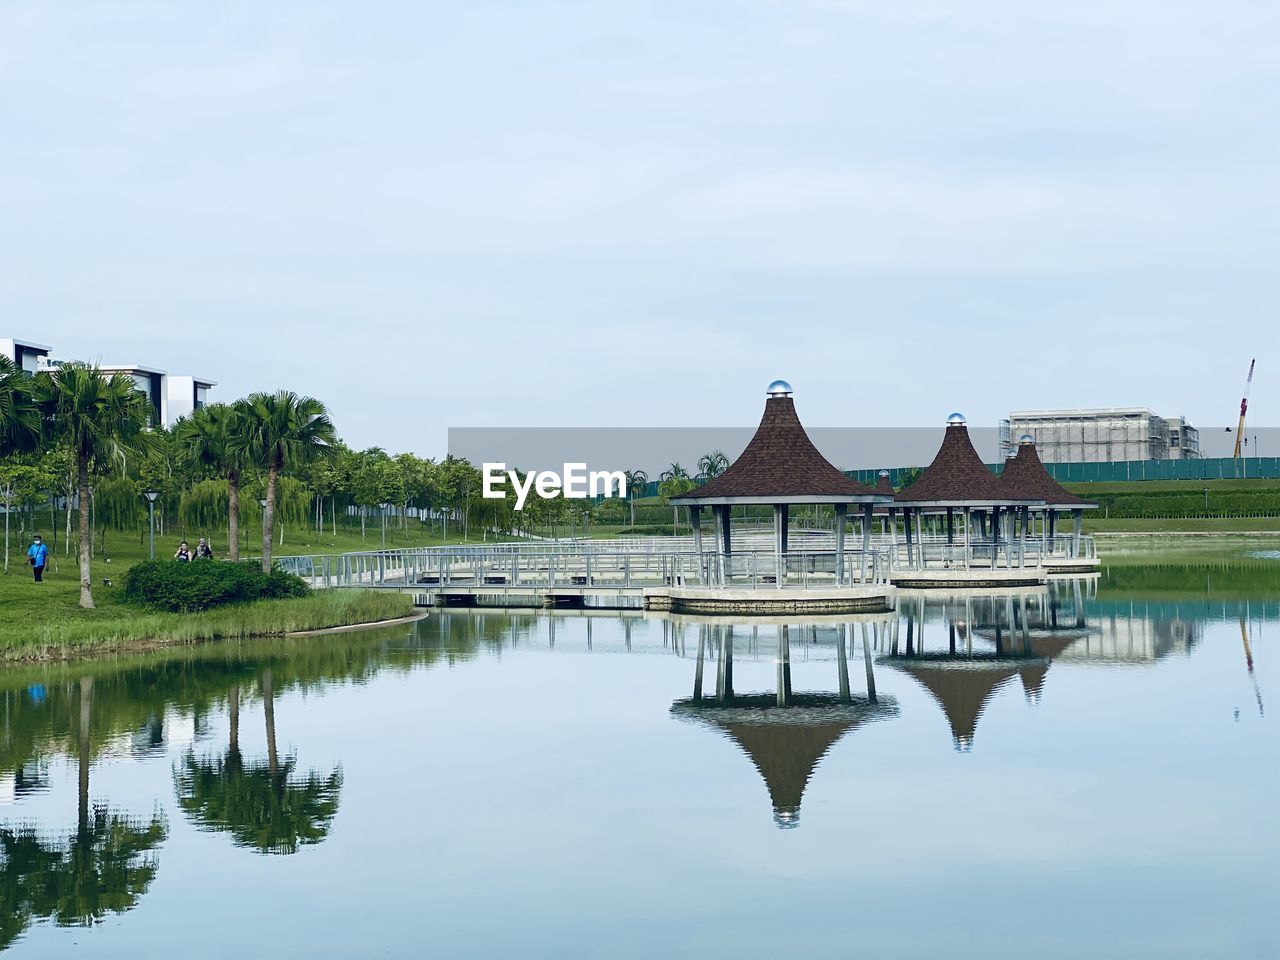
[{"x1": 895, "y1": 413, "x2": 1042, "y2": 571}]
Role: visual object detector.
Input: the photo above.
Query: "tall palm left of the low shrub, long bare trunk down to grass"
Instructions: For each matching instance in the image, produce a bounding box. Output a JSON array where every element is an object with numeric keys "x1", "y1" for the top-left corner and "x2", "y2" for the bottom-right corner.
[{"x1": 35, "y1": 364, "x2": 151, "y2": 609}]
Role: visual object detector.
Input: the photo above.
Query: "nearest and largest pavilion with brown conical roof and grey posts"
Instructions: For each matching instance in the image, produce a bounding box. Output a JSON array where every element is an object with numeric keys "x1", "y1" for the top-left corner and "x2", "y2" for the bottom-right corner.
[{"x1": 671, "y1": 380, "x2": 891, "y2": 586}]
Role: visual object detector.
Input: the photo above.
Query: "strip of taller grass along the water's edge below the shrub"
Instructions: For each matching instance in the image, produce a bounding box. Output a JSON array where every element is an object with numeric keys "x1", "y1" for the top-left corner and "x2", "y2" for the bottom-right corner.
[{"x1": 0, "y1": 585, "x2": 412, "y2": 660}]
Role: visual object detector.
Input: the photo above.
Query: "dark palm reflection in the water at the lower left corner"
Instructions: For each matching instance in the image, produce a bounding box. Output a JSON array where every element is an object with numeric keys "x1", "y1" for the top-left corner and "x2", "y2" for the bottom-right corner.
[{"x1": 0, "y1": 677, "x2": 168, "y2": 948}]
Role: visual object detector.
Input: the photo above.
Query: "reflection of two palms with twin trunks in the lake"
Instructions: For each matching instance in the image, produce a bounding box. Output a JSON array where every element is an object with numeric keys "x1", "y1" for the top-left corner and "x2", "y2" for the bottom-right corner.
[{"x1": 174, "y1": 669, "x2": 342, "y2": 854}]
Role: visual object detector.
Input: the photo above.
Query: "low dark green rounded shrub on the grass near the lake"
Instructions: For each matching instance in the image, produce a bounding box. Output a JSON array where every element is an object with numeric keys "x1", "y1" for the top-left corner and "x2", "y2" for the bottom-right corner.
[{"x1": 124, "y1": 559, "x2": 310, "y2": 613}]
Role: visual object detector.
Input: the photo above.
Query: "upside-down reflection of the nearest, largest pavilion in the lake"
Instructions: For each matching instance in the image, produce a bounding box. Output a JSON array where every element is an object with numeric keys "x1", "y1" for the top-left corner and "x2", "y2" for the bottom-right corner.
[{"x1": 671, "y1": 617, "x2": 897, "y2": 827}]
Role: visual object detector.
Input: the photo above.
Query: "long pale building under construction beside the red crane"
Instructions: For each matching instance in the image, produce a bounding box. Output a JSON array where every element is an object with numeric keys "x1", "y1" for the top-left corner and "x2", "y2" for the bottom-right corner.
[{"x1": 1001, "y1": 407, "x2": 1201, "y2": 463}]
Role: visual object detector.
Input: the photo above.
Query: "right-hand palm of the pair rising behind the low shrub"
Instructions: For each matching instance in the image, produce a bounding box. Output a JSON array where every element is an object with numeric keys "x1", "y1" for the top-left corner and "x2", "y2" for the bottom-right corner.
[{"x1": 229, "y1": 390, "x2": 337, "y2": 573}]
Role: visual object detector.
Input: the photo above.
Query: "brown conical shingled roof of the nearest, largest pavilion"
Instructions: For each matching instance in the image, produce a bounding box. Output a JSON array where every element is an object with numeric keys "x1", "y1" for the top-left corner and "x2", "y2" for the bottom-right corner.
[{"x1": 672, "y1": 396, "x2": 876, "y2": 503}]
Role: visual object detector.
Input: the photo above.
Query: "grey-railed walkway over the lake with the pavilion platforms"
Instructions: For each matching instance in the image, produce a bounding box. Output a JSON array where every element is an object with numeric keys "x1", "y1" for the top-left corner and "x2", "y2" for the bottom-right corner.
[{"x1": 276, "y1": 530, "x2": 1093, "y2": 613}]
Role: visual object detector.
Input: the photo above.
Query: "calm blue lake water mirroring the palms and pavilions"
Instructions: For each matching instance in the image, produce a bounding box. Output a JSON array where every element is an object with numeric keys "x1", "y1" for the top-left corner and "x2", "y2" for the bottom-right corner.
[{"x1": 0, "y1": 562, "x2": 1280, "y2": 957}]
